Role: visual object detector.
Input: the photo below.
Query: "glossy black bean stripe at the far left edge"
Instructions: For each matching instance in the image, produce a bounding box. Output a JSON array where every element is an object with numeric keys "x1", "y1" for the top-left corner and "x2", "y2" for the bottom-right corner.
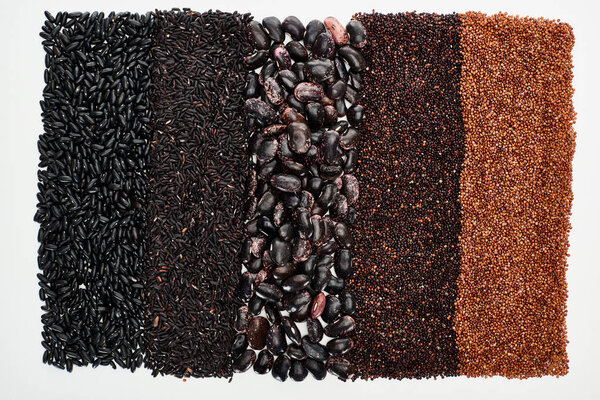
[{"x1": 35, "y1": 12, "x2": 152, "y2": 371}]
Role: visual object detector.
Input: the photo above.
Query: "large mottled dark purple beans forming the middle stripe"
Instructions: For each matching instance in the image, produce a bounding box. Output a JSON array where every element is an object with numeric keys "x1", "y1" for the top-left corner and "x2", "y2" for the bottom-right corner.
[{"x1": 232, "y1": 16, "x2": 365, "y2": 381}]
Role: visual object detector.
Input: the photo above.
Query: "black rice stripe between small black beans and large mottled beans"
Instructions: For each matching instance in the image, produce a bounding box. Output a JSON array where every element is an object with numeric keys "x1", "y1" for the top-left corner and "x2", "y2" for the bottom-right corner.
[{"x1": 145, "y1": 10, "x2": 250, "y2": 377}]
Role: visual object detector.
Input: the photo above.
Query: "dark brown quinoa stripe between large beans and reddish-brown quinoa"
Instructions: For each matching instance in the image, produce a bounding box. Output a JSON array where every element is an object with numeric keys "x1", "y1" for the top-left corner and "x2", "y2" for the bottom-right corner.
[{"x1": 348, "y1": 13, "x2": 463, "y2": 379}]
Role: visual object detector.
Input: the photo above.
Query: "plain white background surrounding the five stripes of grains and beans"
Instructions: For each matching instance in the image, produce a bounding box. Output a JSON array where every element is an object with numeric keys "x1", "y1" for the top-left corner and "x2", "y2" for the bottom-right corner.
[{"x1": 0, "y1": 0, "x2": 600, "y2": 400}]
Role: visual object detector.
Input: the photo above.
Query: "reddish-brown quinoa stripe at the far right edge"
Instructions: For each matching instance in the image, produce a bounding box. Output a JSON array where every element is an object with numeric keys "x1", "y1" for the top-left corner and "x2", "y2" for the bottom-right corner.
[{"x1": 454, "y1": 13, "x2": 575, "y2": 378}]
